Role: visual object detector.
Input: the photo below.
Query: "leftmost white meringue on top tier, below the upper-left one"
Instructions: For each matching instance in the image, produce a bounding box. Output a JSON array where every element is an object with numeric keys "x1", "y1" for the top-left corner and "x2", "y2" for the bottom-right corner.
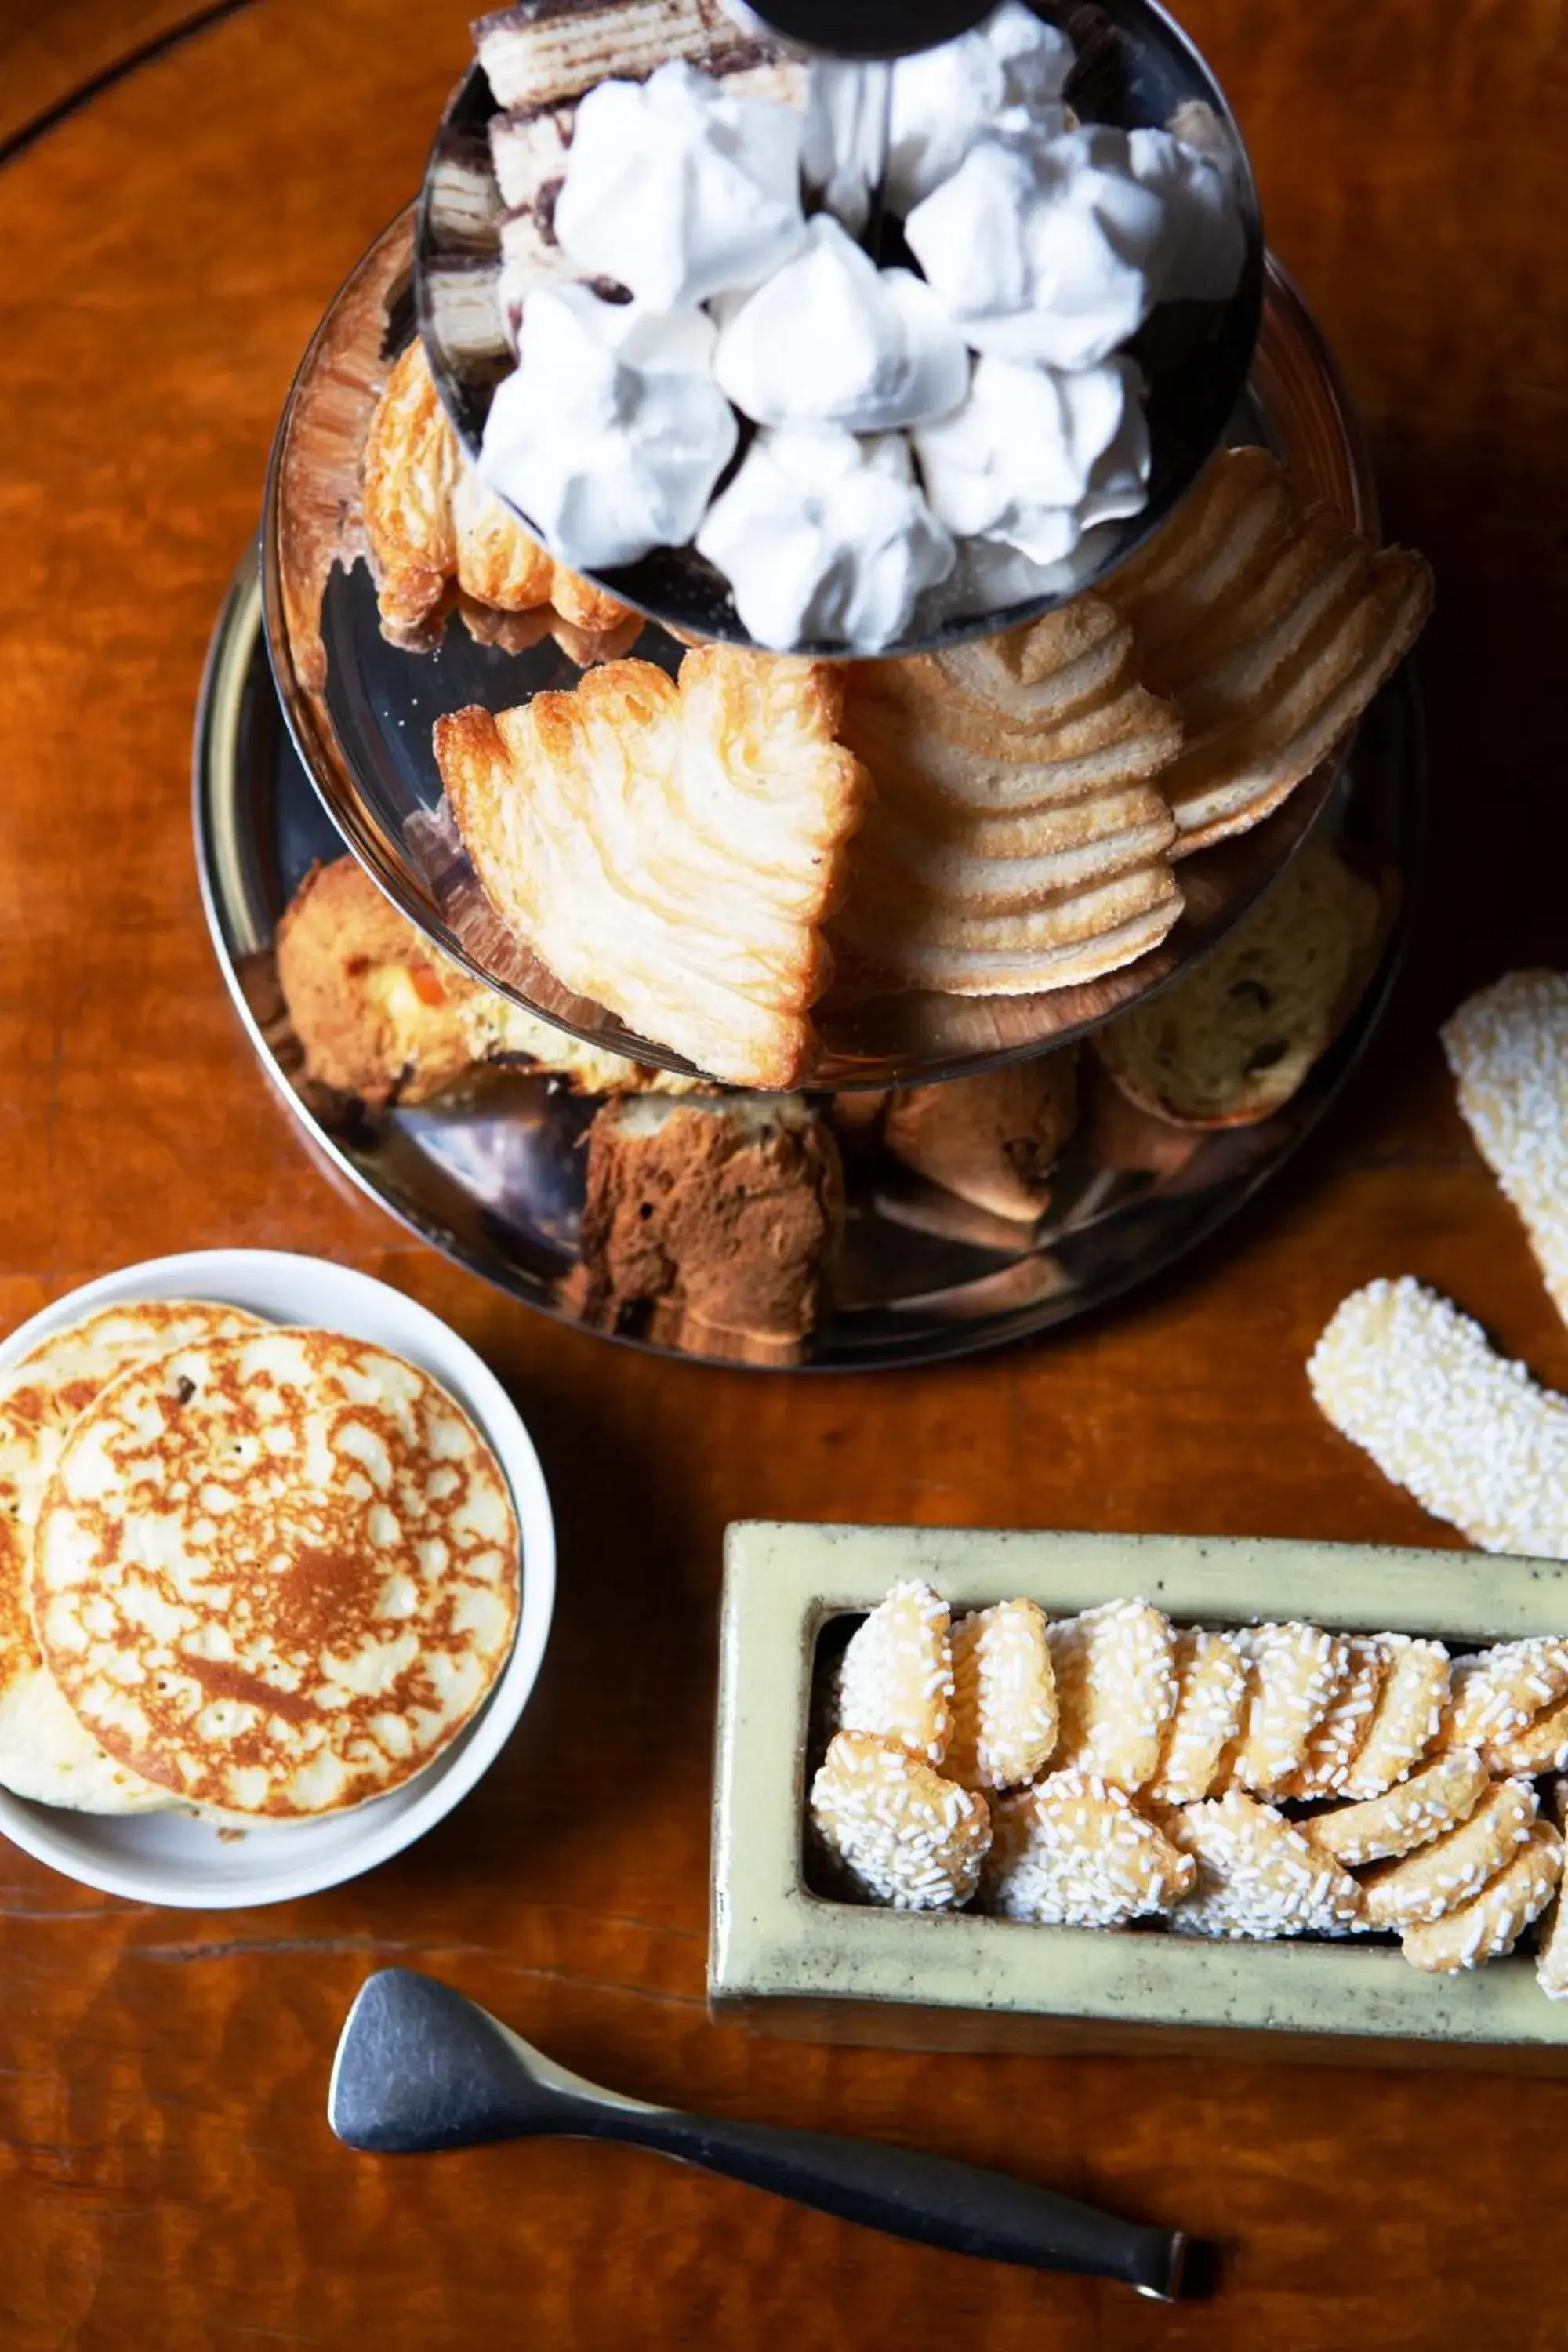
[{"x1": 480, "y1": 285, "x2": 739, "y2": 572}]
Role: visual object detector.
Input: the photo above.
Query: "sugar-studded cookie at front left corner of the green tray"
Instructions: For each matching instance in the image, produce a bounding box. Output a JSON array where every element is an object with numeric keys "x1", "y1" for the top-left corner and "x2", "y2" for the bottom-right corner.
[{"x1": 811, "y1": 1731, "x2": 989, "y2": 1910}]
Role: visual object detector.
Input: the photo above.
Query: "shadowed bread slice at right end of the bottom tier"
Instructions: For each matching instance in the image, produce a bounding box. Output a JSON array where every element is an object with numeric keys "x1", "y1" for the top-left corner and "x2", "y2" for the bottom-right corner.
[{"x1": 1093, "y1": 840, "x2": 1380, "y2": 1127}]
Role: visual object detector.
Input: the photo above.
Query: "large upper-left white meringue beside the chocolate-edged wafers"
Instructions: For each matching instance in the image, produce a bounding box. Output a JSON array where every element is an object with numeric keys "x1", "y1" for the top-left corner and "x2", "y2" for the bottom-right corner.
[{"x1": 555, "y1": 61, "x2": 806, "y2": 310}]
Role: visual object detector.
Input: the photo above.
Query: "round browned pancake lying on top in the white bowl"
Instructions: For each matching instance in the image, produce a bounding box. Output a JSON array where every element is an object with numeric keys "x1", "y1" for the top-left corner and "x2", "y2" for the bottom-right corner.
[{"x1": 33, "y1": 1329, "x2": 520, "y2": 1820}]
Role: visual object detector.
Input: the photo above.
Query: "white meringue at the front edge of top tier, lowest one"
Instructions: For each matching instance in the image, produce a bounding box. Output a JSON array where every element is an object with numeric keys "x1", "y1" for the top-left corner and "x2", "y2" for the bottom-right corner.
[{"x1": 696, "y1": 426, "x2": 954, "y2": 654}]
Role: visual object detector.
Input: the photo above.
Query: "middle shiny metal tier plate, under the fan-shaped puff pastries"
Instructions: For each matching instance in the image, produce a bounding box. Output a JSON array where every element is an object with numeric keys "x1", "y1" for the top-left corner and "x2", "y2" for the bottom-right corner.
[{"x1": 261, "y1": 207, "x2": 1377, "y2": 1089}]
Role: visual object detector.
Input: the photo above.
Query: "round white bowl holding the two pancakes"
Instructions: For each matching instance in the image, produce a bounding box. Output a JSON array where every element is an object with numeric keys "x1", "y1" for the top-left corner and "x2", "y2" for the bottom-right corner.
[{"x1": 0, "y1": 1249, "x2": 555, "y2": 1910}]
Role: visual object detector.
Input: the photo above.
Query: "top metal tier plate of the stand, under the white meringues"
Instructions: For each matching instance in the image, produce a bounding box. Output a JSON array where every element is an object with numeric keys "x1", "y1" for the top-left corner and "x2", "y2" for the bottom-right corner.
[{"x1": 414, "y1": 0, "x2": 1265, "y2": 659}]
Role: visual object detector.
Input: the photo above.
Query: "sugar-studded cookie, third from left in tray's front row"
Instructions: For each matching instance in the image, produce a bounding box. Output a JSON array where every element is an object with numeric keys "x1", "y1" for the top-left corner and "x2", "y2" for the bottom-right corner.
[{"x1": 1159, "y1": 1788, "x2": 1361, "y2": 1938}]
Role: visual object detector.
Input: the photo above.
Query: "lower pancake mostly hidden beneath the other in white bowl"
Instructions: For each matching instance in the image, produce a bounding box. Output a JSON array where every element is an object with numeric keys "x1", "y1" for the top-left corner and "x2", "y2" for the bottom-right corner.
[{"x1": 0, "y1": 1298, "x2": 256, "y2": 1813}]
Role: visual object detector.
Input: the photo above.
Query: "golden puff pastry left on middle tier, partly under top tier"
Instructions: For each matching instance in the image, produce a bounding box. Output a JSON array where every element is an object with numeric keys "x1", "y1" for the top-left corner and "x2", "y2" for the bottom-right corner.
[{"x1": 362, "y1": 336, "x2": 642, "y2": 659}]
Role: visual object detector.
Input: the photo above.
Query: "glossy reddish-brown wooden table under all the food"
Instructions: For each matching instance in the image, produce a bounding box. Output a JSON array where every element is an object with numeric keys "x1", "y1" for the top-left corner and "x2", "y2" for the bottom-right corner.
[{"x1": 0, "y1": 0, "x2": 1568, "y2": 2352}]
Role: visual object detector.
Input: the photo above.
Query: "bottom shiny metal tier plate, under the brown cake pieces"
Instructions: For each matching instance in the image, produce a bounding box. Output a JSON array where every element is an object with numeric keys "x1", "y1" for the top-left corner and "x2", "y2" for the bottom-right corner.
[{"x1": 195, "y1": 564, "x2": 1425, "y2": 1371}]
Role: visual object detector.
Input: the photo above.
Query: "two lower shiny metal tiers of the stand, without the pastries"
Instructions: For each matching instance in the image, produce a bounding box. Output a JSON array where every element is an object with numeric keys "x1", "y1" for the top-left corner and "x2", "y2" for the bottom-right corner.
[{"x1": 195, "y1": 13, "x2": 1425, "y2": 1369}]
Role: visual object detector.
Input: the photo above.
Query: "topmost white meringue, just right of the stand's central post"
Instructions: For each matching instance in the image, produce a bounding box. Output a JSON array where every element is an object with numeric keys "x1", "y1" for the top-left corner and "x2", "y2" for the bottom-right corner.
[{"x1": 886, "y1": 0, "x2": 1072, "y2": 214}]
